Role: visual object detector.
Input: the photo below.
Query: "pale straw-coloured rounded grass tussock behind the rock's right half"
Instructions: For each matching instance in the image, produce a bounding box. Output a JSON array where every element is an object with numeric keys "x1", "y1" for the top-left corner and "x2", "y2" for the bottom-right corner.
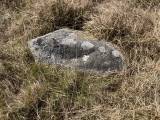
[{"x1": 84, "y1": 1, "x2": 157, "y2": 40}]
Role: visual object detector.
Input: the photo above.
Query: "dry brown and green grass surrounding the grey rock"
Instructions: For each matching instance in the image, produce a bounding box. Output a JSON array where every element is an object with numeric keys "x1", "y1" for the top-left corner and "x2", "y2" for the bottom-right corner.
[{"x1": 0, "y1": 0, "x2": 160, "y2": 120}]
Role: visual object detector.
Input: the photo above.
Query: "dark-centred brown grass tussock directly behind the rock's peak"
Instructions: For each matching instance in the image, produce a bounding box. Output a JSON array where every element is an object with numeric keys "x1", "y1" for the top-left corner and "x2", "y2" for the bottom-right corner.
[{"x1": 38, "y1": 0, "x2": 91, "y2": 34}]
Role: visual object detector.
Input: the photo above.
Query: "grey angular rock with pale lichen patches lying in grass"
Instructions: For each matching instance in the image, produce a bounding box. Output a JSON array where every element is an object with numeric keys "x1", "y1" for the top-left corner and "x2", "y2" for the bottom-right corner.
[{"x1": 28, "y1": 29, "x2": 123, "y2": 73}]
